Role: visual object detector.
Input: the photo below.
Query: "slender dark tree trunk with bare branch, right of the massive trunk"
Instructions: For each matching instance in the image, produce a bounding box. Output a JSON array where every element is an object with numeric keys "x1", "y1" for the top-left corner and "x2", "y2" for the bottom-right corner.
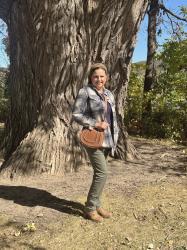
[{"x1": 142, "y1": 0, "x2": 187, "y2": 133}]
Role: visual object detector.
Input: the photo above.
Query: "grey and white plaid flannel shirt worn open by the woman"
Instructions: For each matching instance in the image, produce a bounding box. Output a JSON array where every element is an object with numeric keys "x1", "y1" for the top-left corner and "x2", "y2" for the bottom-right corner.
[{"x1": 72, "y1": 85, "x2": 119, "y2": 155}]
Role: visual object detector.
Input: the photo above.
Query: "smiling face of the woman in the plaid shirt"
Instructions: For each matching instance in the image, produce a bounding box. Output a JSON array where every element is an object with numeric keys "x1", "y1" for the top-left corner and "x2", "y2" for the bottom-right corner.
[{"x1": 91, "y1": 69, "x2": 107, "y2": 90}]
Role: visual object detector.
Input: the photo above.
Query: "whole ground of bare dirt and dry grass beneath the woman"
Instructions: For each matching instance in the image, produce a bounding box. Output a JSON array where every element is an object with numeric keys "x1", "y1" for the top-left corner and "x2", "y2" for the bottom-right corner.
[{"x1": 0, "y1": 138, "x2": 187, "y2": 250}]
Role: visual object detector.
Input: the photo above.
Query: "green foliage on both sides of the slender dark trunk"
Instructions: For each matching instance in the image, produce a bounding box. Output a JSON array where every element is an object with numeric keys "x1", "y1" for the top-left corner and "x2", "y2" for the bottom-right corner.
[{"x1": 125, "y1": 37, "x2": 187, "y2": 141}]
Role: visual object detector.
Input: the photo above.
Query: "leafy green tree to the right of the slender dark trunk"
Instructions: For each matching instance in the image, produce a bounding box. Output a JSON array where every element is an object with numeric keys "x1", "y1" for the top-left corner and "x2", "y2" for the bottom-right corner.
[{"x1": 156, "y1": 37, "x2": 187, "y2": 143}]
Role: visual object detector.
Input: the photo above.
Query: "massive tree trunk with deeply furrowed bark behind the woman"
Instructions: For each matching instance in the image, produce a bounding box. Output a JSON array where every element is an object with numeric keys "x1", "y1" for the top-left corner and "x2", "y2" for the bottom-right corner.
[{"x1": 0, "y1": 0, "x2": 147, "y2": 177}]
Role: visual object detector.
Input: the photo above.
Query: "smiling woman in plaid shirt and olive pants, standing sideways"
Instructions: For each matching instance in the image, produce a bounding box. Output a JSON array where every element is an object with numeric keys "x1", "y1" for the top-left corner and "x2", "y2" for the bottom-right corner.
[{"x1": 73, "y1": 63, "x2": 118, "y2": 222}]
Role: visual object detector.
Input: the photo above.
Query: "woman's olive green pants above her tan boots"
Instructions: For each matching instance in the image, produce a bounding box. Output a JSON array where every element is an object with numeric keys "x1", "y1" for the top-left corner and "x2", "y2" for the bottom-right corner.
[{"x1": 85, "y1": 147, "x2": 110, "y2": 212}]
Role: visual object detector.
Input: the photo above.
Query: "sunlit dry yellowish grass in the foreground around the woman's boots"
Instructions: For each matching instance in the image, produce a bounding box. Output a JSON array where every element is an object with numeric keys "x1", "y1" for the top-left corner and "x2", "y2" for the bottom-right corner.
[{"x1": 0, "y1": 183, "x2": 187, "y2": 250}]
